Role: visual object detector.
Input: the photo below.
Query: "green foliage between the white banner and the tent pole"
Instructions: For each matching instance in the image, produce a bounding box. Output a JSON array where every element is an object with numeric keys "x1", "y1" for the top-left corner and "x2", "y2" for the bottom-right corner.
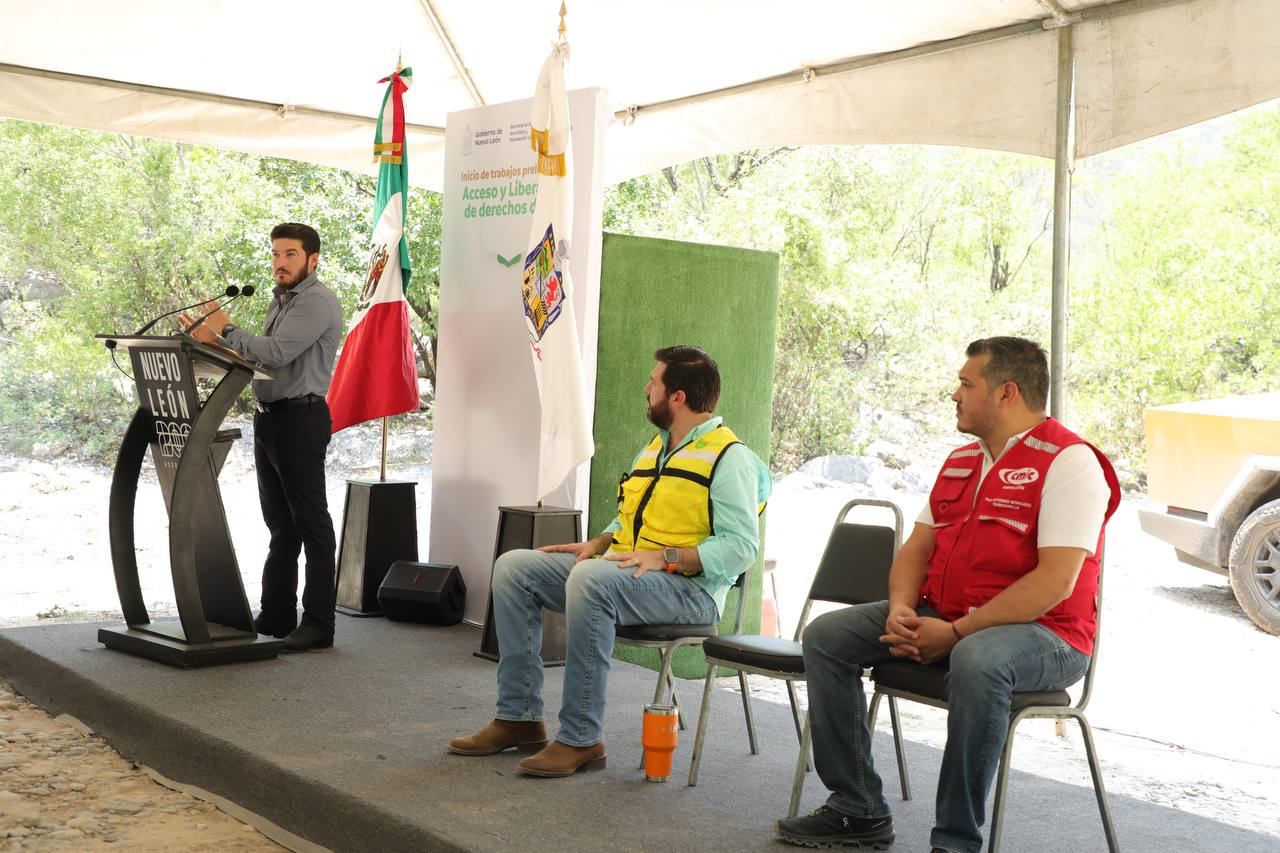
[{"x1": 605, "y1": 146, "x2": 1052, "y2": 471}]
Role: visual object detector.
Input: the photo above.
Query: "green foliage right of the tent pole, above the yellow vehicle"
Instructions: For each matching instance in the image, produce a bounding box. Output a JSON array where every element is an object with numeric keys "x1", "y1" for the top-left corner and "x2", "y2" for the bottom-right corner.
[{"x1": 1069, "y1": 108, "x2": 1280, "y2": 466}]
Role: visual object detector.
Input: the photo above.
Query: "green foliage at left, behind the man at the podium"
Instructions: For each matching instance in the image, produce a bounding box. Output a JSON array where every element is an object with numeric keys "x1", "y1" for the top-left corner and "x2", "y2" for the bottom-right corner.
[{"x1": 0, "y1": 122, "x2": 440, "y2": 455}]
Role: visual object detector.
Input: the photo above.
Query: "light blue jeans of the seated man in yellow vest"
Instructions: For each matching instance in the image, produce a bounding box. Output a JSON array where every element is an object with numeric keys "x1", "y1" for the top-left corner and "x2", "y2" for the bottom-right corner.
[{"x1": 493, "y1": 551, "x2": 717, "y2": 747}]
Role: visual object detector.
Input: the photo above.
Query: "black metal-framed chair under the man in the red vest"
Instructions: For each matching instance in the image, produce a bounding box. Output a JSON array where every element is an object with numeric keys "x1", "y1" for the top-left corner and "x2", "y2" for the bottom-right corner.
[{"x1": 868, "y1": 548, "x2": 1120, "y2": 853}]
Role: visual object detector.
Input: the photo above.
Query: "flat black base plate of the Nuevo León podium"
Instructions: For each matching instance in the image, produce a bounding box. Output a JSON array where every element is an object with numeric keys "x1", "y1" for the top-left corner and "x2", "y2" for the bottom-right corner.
[{"x1": 97, "y1": 620, "x2": 284, "y2": 666}]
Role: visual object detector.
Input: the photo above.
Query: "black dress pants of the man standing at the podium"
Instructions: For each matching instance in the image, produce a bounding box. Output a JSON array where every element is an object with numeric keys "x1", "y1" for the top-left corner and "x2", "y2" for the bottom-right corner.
[{"x1": 253, "y1": 398, "x2": 337, "y2": 634}]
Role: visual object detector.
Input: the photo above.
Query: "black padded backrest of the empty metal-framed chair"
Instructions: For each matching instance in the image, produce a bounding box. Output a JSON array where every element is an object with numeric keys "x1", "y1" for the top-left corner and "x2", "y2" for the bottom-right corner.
[{"x1": 795, "y1": 498, "x2": 902, "y2": 642}]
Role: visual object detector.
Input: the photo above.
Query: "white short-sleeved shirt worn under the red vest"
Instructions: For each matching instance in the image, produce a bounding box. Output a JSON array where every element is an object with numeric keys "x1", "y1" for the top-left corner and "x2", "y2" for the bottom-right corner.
[{"x1": 916, "y1": 429, "x2": 1111, "y2": 555}]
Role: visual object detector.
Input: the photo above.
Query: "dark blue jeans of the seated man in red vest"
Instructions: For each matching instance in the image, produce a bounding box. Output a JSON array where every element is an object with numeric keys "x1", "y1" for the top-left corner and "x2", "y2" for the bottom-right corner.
[{"x1": 804, "y1": 602, "x2": 1089, "y2": 853}]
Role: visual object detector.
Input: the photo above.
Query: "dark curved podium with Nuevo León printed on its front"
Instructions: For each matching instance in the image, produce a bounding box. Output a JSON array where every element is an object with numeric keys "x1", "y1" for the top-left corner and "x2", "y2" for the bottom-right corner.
[{"x1": 97, "y1": 334, "x2": 284, "y2": 666}]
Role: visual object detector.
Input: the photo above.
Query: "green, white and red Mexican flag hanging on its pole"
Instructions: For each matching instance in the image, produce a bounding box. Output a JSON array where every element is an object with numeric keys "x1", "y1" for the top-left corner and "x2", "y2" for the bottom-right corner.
[{"x1": 328, "y1": 68, "x2": 417, "y2": 433}]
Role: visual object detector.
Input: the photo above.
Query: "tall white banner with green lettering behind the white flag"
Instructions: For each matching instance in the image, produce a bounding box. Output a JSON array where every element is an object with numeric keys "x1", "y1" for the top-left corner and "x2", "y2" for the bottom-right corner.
[{"x1": 429, "y1": 86, "x2": 611, "y2": 624}]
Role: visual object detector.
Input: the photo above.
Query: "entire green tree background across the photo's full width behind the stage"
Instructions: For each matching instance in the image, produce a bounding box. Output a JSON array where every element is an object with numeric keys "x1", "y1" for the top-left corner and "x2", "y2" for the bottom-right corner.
[{"x1": 0, "y1": 106, "x2": 1280, "y2": 471}]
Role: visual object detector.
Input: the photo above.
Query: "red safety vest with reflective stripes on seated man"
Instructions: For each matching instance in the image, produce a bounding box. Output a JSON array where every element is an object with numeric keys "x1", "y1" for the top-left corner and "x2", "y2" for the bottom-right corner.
[{"x1": 920, "y1": 418, "x2": 1120, "y2": 654}]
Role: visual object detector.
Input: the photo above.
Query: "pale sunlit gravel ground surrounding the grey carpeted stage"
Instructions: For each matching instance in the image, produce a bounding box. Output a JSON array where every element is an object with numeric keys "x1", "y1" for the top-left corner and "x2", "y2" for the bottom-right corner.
[{"x1": 0, "y1": 424, "x2": 1280, "y2": 850}]
